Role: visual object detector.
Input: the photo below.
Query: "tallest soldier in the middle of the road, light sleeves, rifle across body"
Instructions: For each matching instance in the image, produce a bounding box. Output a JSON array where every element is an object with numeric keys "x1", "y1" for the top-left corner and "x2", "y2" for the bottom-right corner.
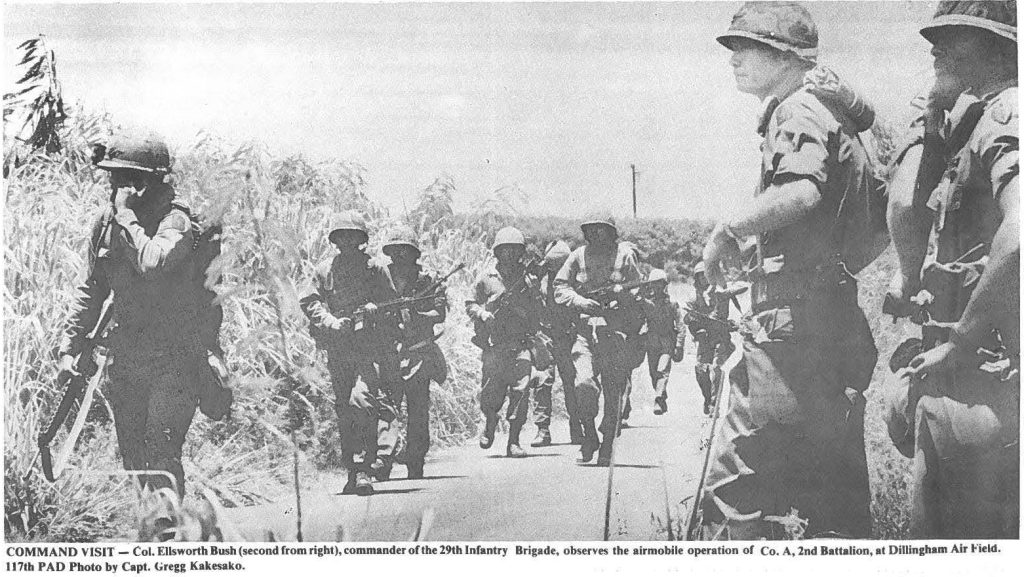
[{"x1": 555, "y1": 216, "x2": 643, "y2": 466}]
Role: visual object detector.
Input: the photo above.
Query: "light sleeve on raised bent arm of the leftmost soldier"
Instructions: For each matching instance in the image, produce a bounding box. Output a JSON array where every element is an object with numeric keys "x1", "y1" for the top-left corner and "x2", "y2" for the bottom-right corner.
[{"x1": 115, "y1": 210, "x2": 195, "y2": 278}]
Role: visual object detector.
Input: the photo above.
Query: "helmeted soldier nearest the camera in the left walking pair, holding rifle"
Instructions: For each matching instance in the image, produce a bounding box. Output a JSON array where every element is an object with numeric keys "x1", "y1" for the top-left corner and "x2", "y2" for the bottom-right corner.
[{"x1": 300, "y1": 211, "x2": 397, "y2": 495}]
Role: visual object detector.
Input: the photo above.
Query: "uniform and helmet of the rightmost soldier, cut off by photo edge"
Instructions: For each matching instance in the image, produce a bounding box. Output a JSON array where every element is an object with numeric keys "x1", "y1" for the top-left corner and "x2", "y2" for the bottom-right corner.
[{"x1": 886, "y1": 2, "x2": 1020, "y2": 539}]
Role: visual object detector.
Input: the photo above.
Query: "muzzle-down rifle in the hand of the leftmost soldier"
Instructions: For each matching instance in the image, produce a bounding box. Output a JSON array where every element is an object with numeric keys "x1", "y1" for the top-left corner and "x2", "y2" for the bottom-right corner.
[{"x1": 37, "y1": 300, "x2": 114, "y2": 483}]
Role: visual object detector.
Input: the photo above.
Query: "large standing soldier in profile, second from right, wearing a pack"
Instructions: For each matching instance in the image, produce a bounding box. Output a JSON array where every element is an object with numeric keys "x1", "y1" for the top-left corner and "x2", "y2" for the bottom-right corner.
[{"x1": 702, "y1": 2, "x2": 877, "y2": 540}]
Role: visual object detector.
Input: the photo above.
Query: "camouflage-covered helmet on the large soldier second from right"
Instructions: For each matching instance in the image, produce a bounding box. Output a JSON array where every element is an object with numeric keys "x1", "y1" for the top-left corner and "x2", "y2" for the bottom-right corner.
[{"x1": 718, "y1": 2, "x2": 818, "y2": 61}]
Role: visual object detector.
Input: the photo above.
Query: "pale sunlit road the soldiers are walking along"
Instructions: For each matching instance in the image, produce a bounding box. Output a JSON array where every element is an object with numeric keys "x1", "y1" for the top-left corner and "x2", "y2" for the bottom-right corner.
[{"x1": 227, "y1": 355, "x2": 709, "y2": 541}]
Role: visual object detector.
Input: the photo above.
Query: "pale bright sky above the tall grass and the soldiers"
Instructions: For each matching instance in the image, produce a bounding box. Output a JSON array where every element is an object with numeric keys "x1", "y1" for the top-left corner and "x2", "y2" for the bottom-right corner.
[{"x1": 3, "y1": 1, "x2": 935, "y2": 218}]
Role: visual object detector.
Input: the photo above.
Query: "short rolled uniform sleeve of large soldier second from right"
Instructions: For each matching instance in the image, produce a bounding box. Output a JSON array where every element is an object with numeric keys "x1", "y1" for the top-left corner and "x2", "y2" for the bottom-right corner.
[{"x1": 766, "y1": 95, "x2": 829, "y2": 187}]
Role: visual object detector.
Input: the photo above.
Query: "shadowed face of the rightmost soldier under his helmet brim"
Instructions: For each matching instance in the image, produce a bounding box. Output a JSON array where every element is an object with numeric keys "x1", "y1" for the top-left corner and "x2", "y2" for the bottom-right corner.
[{"x1": 930, "y1": 26, "x2": 992, "y2": 97}]
